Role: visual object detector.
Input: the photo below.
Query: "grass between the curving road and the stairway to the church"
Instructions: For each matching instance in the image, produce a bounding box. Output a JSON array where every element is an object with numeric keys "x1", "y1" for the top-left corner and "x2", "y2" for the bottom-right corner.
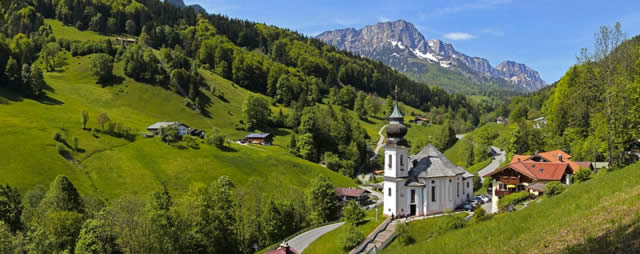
[{"x1": 302, "y1": 209, "x2": 385, "y2": 254}]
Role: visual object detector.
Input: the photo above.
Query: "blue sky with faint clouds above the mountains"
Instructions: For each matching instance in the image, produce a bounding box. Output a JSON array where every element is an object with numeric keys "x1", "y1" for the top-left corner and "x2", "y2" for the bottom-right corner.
[{"x1": 185, "y1": 0, "x2": 640, "y2": 83}]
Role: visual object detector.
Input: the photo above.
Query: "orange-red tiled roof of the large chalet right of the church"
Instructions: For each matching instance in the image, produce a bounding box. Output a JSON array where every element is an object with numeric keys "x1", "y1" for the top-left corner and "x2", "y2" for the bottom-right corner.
[{"x1": 487, "y1": 161, "x2": 569, "y2": 181}]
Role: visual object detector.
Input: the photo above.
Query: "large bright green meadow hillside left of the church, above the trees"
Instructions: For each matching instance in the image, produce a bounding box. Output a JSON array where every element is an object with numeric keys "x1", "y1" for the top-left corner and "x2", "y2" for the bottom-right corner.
[{"x1": 0, "y1": 49, "x2": 354, "y2": 198}]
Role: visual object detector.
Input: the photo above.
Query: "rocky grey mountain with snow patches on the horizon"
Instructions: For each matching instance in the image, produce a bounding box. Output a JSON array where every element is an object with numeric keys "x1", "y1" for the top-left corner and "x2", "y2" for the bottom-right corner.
[{"x1": 316, "y1": 20, "x2": 547, "y2": 91}]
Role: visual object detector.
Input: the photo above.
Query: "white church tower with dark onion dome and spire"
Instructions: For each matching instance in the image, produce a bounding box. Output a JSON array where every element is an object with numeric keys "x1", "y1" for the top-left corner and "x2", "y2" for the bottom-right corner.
[{"x1": 383, "y1": 86, "x2": 411, "y2": 216}]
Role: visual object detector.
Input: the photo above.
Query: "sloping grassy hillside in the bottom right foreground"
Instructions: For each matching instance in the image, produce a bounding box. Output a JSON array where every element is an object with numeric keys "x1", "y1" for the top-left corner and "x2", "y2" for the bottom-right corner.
[{"x1": 385, "y1": 164, "x2": 640, "y2": 253}]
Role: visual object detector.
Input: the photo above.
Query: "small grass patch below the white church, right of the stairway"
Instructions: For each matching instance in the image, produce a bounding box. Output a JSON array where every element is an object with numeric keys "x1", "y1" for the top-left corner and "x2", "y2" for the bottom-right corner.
[{"x1": 384, "y1": 213, "x2": 468, "y2": 252}]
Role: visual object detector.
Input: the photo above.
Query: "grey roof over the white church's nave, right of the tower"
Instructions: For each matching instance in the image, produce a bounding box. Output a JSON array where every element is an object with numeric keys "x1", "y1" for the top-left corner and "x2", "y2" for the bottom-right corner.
[{"x1": 409, "y1": 144, "x2": 470, "y2": 178}]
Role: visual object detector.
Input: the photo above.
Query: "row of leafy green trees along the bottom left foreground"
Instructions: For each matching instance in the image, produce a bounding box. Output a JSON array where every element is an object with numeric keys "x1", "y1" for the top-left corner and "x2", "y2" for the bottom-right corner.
[{"x1": 0, "y1": 176, "x2": 348, "y2": 253}]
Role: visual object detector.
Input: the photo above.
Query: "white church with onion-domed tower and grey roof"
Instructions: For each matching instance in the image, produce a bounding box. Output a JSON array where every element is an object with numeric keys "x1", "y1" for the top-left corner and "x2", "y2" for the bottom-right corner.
[{"x1": 383, "y1": 101, "x2": 474, "y2": 217}]
